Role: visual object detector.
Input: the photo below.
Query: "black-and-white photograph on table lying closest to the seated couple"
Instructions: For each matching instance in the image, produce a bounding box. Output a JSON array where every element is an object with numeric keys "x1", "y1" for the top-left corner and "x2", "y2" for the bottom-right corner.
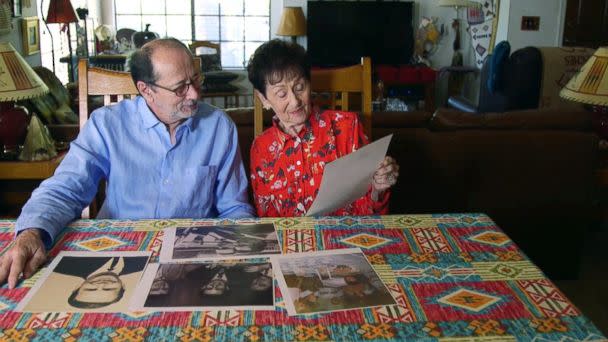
[{"x1": 160, "y1": 223, "x2": 281, "y2": 262}]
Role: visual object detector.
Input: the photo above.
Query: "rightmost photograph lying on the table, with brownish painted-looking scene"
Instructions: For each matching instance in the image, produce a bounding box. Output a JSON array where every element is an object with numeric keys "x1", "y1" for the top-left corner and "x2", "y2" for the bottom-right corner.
[{"x1": 271, "y1": 248, "x2": 396, "y2": 316}]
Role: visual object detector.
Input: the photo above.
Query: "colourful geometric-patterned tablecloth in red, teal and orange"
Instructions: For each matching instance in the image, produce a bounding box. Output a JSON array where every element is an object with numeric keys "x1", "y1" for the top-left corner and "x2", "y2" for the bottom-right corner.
[{"x1": 0, "y1": 214, "x2": 606, "y2": 341}]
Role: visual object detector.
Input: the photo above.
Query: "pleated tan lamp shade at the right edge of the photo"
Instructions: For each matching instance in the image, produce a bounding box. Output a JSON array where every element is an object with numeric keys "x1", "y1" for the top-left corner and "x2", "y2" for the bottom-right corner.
[{"x1": 559, "y1": 47, "x2": 608, "y2": 106}]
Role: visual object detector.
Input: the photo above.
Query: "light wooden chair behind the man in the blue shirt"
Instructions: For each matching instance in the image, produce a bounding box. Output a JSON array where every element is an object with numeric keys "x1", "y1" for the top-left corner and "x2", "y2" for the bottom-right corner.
[{"x1": 78, "y1": 57, "x2": 201, "y2": 218}]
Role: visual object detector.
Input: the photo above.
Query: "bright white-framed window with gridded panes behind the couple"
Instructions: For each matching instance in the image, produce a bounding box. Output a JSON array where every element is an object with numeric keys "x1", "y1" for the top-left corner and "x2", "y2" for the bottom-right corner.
[{"x1": 115, "y1": 0, "x2": 270, "y2": 69}]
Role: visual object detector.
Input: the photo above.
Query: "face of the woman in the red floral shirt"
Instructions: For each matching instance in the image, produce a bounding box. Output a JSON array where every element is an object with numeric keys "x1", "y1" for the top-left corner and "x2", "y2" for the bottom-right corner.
[{"x1": 256, "y1": 72, "x2": 311, "y2": 134}]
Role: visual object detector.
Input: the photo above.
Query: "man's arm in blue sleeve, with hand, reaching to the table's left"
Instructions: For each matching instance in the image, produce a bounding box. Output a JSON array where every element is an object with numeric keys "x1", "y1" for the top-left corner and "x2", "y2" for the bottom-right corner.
[{"x1": 0, "y1": 112, "x2": 108, "y2": 288}]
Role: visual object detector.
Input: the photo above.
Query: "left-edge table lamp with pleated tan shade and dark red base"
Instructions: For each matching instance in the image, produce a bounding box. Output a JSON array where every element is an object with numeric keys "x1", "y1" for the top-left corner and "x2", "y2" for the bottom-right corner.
[{"x1": 0, "y1": 43, "x2": 49, "y2": 155}]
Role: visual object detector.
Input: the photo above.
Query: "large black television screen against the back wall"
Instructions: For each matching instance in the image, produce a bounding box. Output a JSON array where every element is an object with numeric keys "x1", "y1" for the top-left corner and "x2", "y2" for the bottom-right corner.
[{"x1": 306, "y1": 1, "x2": 414, "y2": 66}]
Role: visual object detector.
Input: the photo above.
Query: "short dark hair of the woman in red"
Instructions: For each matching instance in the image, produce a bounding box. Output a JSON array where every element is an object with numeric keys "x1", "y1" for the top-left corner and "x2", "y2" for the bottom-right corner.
[{"x1": 247, "y1": 39, "x2": 310, "y2": 96}]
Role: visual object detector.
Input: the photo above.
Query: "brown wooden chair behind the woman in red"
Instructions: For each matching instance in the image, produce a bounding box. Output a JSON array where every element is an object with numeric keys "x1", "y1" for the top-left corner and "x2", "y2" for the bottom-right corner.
[{"x1": 253, "y1": 57, "x2": 372, "y2": 139}]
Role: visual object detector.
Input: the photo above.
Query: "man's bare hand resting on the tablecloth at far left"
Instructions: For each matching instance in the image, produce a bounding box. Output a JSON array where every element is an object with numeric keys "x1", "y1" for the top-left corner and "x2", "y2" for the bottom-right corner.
[{"x1": 0, "y1": 228, "x2": 46, "y2": 289}]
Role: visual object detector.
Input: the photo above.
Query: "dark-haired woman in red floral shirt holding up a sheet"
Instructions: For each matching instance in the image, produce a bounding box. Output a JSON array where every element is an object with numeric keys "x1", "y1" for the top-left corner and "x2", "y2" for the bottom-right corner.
[{"x1": 247, "y1": 40, "x2": 399, "y2": 217}]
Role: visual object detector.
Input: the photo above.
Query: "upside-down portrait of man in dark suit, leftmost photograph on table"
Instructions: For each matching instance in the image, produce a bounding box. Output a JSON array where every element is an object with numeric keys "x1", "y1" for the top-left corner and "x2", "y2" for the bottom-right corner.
[{"x1": 16, "y1": 251, "x2": 150, "y2": 312}]
